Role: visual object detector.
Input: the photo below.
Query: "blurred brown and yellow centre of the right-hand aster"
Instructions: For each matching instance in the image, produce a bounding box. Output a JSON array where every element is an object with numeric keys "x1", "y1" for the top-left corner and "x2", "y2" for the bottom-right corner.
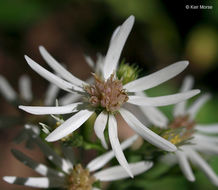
[{"x1": 163, "y1": 115, "x2": 195, "y2": 145}]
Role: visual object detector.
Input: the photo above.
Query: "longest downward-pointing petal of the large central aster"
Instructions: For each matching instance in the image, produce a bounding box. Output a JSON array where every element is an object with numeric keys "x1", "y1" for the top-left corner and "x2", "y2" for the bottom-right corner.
[{"x1": 108, "y1": 115, "x2": 133, "y2": 177}]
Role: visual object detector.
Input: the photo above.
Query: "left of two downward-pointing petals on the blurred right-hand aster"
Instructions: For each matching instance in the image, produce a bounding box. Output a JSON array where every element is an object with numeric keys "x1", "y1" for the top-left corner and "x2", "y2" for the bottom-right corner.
[{"x1": 175, "y1": 151, "x2": 195, "y2": 181}]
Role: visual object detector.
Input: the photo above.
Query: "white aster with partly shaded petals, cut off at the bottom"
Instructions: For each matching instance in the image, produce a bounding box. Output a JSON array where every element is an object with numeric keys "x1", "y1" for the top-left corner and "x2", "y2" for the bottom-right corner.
[{"x1": 3, "y1": 126, "x2": 153, "y2": 190}]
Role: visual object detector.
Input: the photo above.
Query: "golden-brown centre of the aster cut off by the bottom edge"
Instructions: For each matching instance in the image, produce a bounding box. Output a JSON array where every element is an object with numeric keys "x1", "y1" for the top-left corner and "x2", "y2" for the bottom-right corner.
[{"x1": 67, "y1": 164, "x2": 95, "y2": 190}]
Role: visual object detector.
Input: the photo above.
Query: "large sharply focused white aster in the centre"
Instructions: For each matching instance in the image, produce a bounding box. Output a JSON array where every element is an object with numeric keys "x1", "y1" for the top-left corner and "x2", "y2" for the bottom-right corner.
[{"x1": 20, "y1": 16, "x2": 199, "y2": 176}]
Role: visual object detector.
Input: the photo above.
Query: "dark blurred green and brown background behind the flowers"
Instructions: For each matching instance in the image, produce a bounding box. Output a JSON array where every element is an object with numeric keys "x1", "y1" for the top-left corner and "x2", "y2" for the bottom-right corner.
[{"x1": 0, "y1": 0, "x2": 218, "y2": 190}]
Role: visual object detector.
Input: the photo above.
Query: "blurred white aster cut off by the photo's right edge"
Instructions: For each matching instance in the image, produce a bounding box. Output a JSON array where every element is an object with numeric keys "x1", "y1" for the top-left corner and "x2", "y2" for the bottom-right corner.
[{"x1": 143, "y1": 76, "x2": 218, "y2": 186}]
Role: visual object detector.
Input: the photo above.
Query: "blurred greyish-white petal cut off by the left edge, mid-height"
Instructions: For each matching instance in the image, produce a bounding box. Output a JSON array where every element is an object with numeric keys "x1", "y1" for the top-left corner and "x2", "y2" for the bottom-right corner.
[{"x1": 0, "y1": 75, "x2": 17, "y2": 101}]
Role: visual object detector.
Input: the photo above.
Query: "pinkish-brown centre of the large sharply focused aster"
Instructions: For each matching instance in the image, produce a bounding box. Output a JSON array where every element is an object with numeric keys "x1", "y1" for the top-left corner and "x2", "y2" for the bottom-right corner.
[{"x1": 85, "y1": 74, "x2": 128, "y2": 113}]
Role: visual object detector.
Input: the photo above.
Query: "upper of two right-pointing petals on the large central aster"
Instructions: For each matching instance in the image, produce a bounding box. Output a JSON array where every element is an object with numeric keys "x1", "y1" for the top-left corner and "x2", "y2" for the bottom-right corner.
[{"x1": 123, "y1": 61, "x2": 188, "y2": 92}]
